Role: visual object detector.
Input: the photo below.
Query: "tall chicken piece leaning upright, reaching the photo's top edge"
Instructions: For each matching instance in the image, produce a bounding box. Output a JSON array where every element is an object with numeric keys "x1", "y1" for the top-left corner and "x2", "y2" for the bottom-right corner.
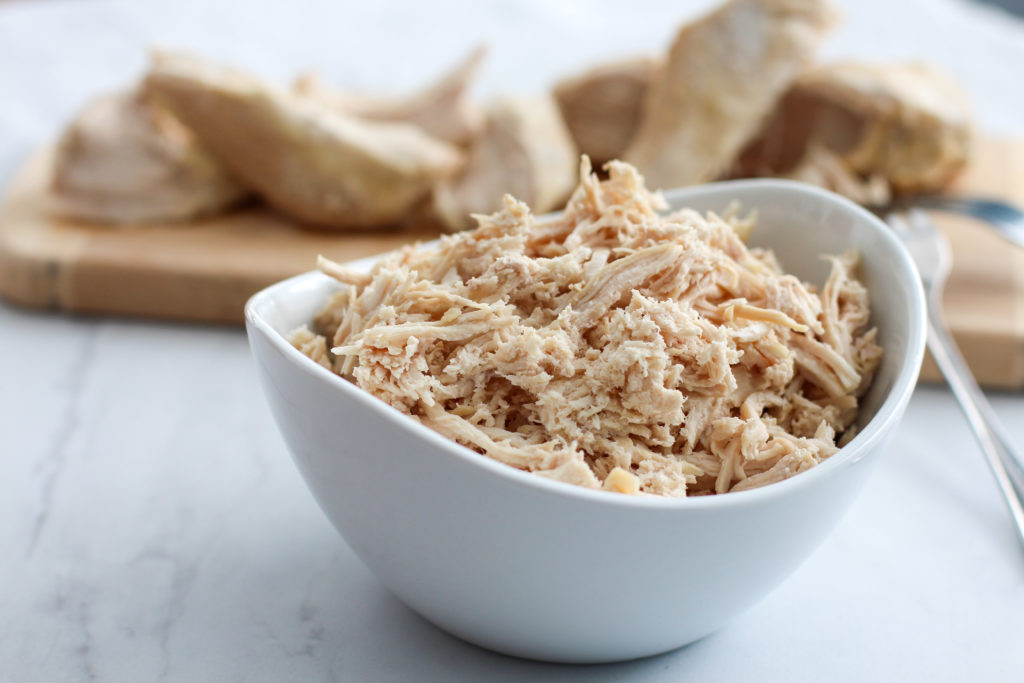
[{"x1": 625, "y1": 0, "x2": 834, "y2": 187}]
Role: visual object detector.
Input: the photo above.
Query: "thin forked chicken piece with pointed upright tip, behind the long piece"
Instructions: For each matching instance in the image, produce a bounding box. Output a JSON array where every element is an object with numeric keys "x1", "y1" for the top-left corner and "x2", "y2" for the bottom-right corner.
[{"x1": 295, "y1": 46, "x2": 486, "y2": 145}]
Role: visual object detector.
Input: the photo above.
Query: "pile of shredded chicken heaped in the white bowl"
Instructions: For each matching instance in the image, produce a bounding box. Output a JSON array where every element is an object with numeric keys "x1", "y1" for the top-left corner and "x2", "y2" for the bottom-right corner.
[{"x1": 292, "y1": 159, "x2": 882, "y2": 497}]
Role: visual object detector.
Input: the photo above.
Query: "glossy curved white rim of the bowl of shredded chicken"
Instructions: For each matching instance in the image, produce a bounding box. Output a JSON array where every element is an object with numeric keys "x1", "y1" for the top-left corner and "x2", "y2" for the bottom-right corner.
[{"x1": 245, "y1": 178, "x2": 927, "y2": 510}]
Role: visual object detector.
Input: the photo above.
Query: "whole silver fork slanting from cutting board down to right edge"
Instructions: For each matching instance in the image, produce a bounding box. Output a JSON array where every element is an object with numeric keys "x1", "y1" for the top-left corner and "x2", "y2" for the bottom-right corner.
[{"x1": 886, "y1": 209, "x2": 1024, "y2": 543}]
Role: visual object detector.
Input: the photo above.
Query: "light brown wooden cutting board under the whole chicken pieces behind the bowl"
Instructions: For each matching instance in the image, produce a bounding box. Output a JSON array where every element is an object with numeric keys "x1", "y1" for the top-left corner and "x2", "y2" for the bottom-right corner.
[{"x1": 0, "y1": 139, "x2": 1024, "y2": 388}]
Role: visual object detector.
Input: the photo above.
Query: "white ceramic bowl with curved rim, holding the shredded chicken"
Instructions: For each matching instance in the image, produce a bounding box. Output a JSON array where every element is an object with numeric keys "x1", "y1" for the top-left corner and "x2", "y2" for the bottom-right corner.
[{"x1": 246, "y1": 180, "x2": 925, "y2": 663}]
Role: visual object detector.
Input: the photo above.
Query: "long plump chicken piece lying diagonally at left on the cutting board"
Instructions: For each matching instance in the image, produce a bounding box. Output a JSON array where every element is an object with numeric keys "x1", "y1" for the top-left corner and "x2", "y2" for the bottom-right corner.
[{"x1": 146, "y1": 53, "x2": 460, "y2": 228}]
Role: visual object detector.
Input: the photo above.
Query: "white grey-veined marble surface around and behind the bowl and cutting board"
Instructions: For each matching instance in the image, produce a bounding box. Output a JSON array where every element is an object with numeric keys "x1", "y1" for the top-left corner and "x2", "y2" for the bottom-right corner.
[{"x1": 0, "y1": 0, "x2": 1024, "y2": 681}]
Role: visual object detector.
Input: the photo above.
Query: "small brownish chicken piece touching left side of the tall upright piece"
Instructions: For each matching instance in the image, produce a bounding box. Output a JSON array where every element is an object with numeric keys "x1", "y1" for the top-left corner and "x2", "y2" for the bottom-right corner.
[{"x1": 554, "y1": 57, "x2": 657, "y2": 166}]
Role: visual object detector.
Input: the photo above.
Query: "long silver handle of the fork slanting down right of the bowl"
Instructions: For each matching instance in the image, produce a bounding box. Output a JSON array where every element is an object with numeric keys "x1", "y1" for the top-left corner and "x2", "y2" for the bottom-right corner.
[{"x1": 928, "y1": 306, "x2": 1024, "y2": 543}]
